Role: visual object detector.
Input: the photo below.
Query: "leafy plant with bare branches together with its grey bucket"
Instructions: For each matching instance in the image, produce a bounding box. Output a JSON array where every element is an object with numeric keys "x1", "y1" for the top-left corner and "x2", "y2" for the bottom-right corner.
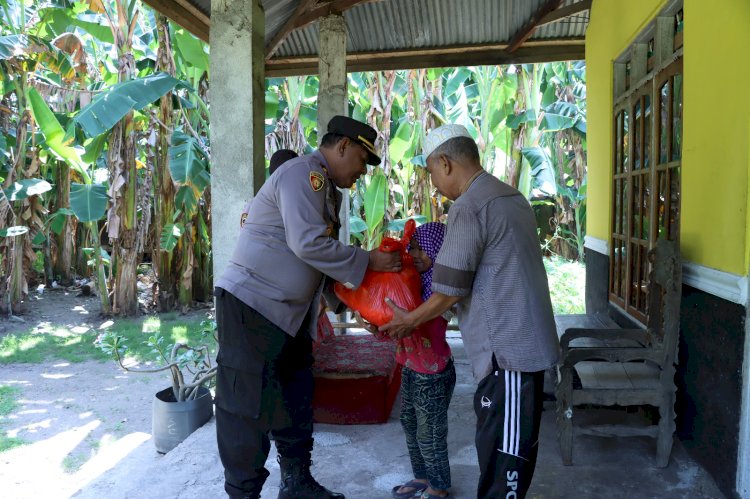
[{"x1": 97, "y1": 320, "x2": 216, "y2": 453}]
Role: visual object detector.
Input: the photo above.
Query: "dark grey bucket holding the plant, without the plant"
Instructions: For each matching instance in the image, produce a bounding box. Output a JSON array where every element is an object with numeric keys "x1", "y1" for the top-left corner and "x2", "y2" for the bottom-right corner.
[{"x1": 151, "y1": 387, "x2": 214, "y2": 454}]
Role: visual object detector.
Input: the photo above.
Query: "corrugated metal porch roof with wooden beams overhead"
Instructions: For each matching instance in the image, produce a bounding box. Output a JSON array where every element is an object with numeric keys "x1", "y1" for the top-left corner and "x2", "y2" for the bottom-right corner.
[{"x1": 145, "y1": 0, "x2": 591, "y2": 75}]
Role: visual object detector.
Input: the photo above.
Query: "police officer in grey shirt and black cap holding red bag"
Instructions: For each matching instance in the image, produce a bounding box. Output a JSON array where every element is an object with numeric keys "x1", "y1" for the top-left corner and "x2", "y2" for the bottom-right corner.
[{"x1": 214, "y1": 116, "x2": 401, "y2": 499}]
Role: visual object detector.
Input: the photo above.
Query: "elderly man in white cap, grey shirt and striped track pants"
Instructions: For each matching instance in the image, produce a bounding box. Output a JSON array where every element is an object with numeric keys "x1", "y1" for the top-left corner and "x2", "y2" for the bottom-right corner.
[{"x1": 380, "y1": 125, "x2": 560, "y2": 498}]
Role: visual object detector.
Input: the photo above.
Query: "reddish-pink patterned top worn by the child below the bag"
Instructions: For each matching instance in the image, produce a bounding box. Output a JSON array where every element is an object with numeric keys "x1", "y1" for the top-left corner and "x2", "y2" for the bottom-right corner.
[{"x1": 396, "y1": 317, "x2": 452, "y2": 374}]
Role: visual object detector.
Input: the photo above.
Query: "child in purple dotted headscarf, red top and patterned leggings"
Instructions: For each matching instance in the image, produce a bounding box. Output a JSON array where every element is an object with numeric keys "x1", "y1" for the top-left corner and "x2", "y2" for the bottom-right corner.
[{"x1": 392, "y1": 222, "x2": 456, "y2": 499}]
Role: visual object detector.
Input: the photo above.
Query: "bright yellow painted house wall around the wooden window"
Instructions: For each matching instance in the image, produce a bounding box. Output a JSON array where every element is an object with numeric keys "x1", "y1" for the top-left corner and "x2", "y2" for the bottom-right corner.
[{"x1": 586, "y1": 0, "x2": 750, "y2": 275}]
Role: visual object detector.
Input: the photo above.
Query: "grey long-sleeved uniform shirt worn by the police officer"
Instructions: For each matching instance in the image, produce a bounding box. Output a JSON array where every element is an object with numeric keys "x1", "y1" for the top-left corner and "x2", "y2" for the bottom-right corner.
[{"x1": 216, "y1": 151, "x2": 369, "y2": 336}]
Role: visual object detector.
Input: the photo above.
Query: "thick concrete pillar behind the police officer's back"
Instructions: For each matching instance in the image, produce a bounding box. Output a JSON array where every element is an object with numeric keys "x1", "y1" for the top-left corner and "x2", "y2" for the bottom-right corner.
[{"x1": 210, "y1": 0, "x2": 265, "y2": 279}]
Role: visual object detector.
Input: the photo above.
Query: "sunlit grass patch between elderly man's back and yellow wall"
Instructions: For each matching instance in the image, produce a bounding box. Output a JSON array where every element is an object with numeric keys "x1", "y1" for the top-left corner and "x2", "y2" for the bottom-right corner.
[{"x1": 544, "y1": 256, "x2": 586, "y2": 314}]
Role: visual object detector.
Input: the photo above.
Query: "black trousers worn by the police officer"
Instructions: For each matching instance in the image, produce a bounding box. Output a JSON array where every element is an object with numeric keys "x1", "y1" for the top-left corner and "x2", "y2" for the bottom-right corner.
[{"x1": 214, "y1": 288, "x2": 313, "y2": 497}]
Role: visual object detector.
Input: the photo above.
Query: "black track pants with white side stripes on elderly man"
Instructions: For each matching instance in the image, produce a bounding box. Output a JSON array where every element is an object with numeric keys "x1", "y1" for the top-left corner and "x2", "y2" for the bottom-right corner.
[{"x1": 474, "y1": 358, "x2": 544, "y2": 499}]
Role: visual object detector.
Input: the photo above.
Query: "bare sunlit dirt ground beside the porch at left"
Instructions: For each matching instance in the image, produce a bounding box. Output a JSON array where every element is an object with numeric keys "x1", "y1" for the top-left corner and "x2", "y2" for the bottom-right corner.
[{"x1": 0, "y1": 289, "x2": 212, "y2": 499}]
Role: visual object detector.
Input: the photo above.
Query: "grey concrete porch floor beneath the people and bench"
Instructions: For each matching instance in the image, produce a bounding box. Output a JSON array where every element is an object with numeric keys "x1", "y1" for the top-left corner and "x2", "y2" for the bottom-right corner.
[{"x1": 75, "y1": 336, "x2": 724, "y2": 499}]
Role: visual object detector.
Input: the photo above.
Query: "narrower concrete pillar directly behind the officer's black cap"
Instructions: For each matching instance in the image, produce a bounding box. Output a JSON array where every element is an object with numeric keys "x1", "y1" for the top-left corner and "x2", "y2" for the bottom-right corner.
[{"x1": 318, "y1": 14, "x2": 349, "y2": 244}]
